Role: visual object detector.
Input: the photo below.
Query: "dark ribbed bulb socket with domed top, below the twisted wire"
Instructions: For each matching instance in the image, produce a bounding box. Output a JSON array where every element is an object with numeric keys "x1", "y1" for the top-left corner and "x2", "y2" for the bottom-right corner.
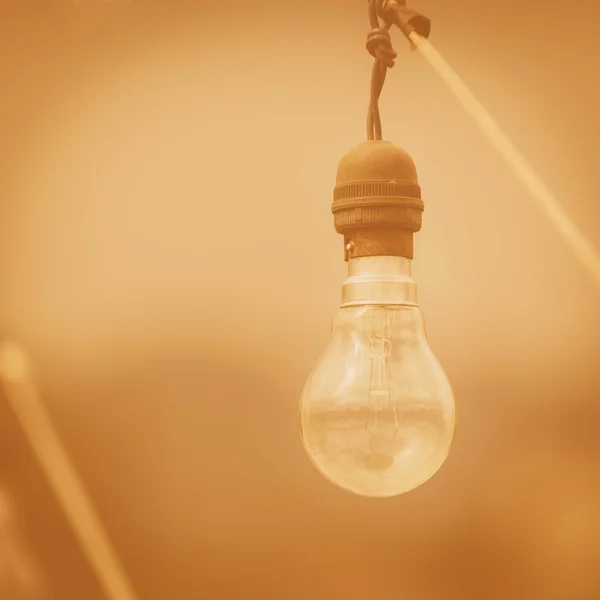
[{"x1": 331, "y1": 141, "x2": 424, "y2": 261}]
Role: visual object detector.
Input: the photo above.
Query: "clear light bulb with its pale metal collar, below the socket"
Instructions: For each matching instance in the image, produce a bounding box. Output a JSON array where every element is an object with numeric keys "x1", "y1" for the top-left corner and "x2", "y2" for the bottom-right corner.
[{"x1": 300, "y1": 256, "x2": 455, "y2": 497}]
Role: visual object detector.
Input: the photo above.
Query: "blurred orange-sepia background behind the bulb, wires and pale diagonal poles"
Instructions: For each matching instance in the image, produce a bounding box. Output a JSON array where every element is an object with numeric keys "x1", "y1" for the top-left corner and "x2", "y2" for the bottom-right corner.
[{"x1": 0, "y1": 0, "x2": 600, "y2": 600}]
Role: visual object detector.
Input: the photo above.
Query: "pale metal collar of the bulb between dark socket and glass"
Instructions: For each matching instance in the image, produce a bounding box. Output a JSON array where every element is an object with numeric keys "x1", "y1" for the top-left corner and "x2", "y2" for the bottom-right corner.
[{"x1": 342, "y1": 256, "x2": 418, "y2": 308}]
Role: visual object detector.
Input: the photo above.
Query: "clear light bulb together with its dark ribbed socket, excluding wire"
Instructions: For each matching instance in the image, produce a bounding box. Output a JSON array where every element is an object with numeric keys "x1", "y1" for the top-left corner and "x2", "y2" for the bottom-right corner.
[{"x1": 300, "y1": 141, "x2": 455, "y2": 497}]
